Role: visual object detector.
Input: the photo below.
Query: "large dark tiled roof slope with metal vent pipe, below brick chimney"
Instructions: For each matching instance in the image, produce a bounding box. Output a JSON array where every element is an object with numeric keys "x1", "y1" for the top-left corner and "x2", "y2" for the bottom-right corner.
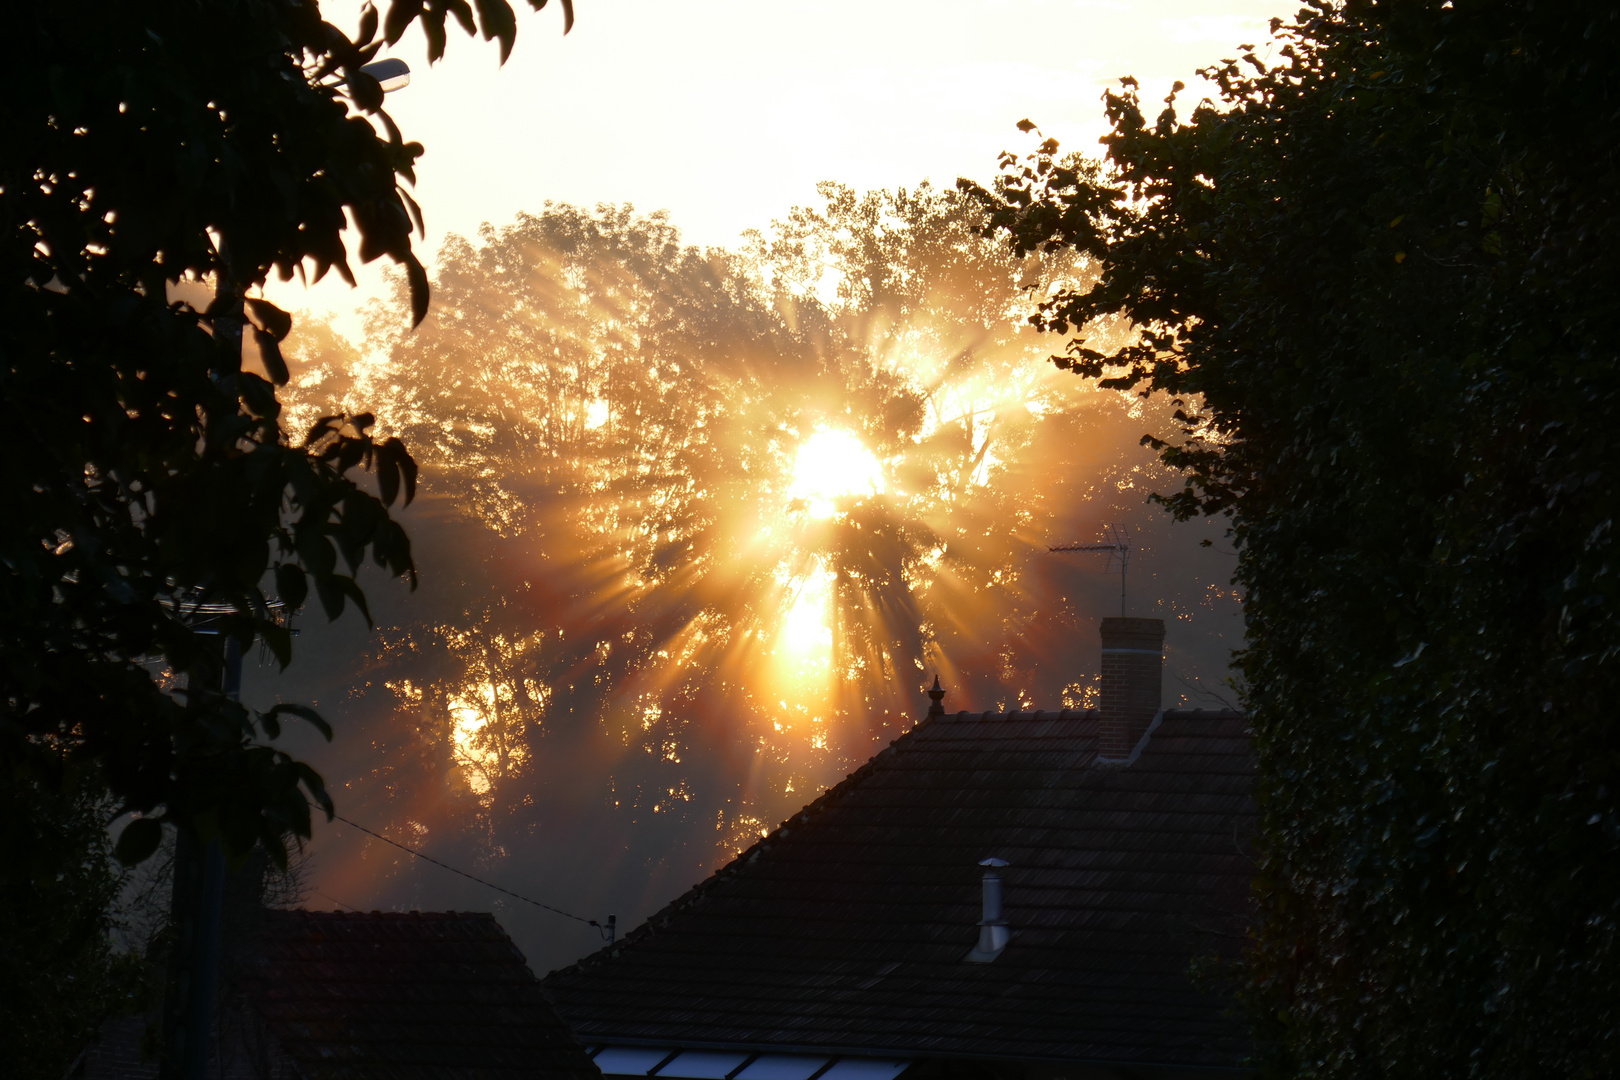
[{"x1": 546, "y1": 711, "x2": 1256, "y2": 1069}]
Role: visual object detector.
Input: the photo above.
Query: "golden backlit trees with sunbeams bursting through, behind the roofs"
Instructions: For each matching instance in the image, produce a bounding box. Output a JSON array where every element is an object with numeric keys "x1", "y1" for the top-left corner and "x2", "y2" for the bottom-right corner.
[{"x1": 278, "y1": 185, "x2": 1234, "y2": 945}]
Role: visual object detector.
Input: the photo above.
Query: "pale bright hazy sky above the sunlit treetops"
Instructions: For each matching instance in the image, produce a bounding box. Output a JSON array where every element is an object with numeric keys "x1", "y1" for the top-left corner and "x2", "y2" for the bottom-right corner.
[{"x1": 274, "y1": 0, "x2": 1296, "y2": 332}]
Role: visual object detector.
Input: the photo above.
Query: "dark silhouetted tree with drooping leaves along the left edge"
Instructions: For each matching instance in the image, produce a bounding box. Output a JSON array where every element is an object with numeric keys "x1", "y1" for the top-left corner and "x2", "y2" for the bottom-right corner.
[{"x1": 0, "y1": 0, "x2": 572, "y2": 1075}]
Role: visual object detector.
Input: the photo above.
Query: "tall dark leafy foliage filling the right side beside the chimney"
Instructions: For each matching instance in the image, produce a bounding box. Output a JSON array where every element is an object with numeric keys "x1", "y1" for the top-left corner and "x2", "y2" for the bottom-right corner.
[{"x1": 977, "y1": 0, "x2": 1620, "y2": 1077}]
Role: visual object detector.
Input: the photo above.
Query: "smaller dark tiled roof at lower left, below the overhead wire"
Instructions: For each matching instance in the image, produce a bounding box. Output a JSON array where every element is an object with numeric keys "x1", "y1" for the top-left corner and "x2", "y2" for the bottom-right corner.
[{"x1": 246, "y1": 912, "x2": 599, "y2": 1080}]
